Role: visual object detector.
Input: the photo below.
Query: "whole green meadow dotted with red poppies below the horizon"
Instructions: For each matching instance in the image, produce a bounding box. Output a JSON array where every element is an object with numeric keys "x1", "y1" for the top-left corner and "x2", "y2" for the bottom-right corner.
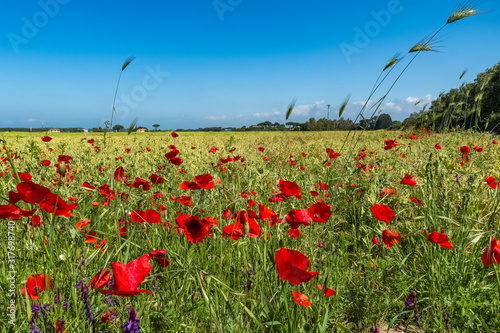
[{"x1": 0, "y1": 130, "x2": 500, "y2": 332}]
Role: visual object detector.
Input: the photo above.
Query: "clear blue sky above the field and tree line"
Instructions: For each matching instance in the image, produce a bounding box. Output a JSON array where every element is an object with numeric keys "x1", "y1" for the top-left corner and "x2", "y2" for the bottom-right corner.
[{"x1": 0, "y1": 0, "x2": 500, "y2": 129}]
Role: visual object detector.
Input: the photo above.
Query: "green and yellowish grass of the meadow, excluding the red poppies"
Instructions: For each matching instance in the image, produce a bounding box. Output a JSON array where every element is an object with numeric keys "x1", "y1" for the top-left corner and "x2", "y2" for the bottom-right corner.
[{"x1": 0, "y1": 131, "x2": 500, "y2": 332}]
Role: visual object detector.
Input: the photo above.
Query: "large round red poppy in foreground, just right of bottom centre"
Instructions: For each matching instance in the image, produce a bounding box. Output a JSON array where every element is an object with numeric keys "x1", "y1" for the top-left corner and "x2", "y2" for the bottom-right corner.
[{"x1": 275, "y1": 247, "x2": 319, "y2": 285}]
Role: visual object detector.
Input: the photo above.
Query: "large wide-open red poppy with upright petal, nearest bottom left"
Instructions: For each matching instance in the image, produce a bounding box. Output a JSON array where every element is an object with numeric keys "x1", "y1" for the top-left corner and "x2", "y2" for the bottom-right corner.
[{"x1": 99, "y1": 253, "x2": 153, "y2": 297}]
